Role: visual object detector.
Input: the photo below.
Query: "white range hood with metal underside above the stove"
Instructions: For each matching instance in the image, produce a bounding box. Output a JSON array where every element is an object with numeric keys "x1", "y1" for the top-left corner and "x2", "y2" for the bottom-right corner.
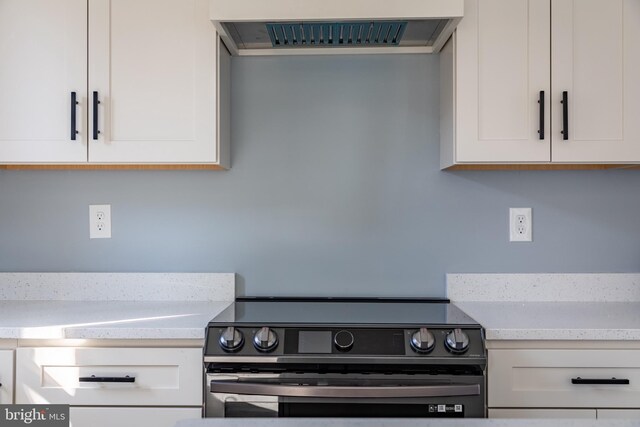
[{"x1": 210, "y1": 0, "x2": 464, "y2": 55}]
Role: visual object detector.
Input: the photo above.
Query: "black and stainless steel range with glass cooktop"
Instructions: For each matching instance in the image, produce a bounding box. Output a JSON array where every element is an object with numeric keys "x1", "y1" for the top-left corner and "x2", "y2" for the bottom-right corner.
[{"x1": 204, "y1": 298, "x2": 487, "y2": 418}]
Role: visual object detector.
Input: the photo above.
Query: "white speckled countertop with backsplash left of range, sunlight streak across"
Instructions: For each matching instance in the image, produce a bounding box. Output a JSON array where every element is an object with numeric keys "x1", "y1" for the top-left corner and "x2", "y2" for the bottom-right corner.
[{"x1": 0, "y1": 273, "x2": 235, "y2": 340}]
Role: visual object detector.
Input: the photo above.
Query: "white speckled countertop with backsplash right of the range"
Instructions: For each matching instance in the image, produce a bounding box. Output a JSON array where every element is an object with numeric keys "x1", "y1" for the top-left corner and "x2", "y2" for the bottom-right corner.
[{"x1": 447, "y1": 274, "x2": 640, "y2": 341}]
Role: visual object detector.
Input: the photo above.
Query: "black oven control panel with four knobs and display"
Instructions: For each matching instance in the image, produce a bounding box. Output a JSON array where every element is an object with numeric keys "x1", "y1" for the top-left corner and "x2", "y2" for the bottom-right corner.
[{"x1": 205, "y1": 326, "x2": 484, "y2": 358}]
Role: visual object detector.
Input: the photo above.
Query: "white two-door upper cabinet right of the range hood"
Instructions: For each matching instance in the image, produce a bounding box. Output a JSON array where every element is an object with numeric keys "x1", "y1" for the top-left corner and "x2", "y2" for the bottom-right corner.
[{"x1": 441, "y1": 0, "x2": 640, "y2": 168}]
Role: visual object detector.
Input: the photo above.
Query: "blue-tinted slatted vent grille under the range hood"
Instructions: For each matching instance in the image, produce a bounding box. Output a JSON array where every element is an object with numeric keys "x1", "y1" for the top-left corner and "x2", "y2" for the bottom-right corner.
[{"x1": 266, "y1": 21, "x2": 407, "y2": 48}]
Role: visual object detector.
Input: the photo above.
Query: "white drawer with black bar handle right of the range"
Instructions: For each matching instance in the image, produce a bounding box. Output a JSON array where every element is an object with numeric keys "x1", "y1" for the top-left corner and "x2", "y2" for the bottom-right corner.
[{"x1": 487, "y1": 350, "x2": 640, "y2": 408}]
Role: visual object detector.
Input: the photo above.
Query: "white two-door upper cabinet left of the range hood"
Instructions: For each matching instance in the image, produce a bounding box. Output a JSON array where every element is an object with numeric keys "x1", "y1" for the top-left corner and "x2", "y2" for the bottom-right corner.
[{"x1": 0, "y1": 0, "x2": 230, "y2": 168}]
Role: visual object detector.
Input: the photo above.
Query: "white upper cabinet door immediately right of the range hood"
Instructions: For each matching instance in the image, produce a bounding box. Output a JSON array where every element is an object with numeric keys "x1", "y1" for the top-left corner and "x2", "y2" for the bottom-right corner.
[{"x1": 455, "y1": 0, "x2": 551, "y2": 163}]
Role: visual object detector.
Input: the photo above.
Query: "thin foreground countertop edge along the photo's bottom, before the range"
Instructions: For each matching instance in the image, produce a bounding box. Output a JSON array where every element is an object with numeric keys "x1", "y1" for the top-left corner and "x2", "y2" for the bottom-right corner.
[{"x1": 176, "y1": 418, "x2": 640, "y2": 427}]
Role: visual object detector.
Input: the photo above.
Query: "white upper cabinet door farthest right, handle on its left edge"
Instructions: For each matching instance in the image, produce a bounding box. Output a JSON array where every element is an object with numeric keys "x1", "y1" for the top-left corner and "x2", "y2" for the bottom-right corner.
[{"x1": 552, "y1": 0, "x2": 640, "y2": 163}]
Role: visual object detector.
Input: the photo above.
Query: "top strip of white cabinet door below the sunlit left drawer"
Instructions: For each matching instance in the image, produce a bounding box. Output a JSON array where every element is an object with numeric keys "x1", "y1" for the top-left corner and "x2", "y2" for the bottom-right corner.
[{"x1": 70, "y1": 407, "x2": 202, "y2": 427}]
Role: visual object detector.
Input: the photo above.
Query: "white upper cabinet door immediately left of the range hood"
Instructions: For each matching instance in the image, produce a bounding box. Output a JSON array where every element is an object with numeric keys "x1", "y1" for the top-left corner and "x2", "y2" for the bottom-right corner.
[{"x1": 87, "y1": 0, "x2": 219, "y2": 163}]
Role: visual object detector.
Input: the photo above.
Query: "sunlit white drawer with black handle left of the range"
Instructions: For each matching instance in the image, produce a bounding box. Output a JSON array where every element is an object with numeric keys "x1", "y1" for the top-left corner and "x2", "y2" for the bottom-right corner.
[{"x1": 16, "y1": 347, "x2": 202, "y2": 406}]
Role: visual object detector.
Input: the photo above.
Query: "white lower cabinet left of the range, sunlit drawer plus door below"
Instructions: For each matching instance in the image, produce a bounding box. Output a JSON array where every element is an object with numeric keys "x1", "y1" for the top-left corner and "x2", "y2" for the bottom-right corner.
[{"x1": 15, "y1": 347, "x2": 203, "y2": 427}]
